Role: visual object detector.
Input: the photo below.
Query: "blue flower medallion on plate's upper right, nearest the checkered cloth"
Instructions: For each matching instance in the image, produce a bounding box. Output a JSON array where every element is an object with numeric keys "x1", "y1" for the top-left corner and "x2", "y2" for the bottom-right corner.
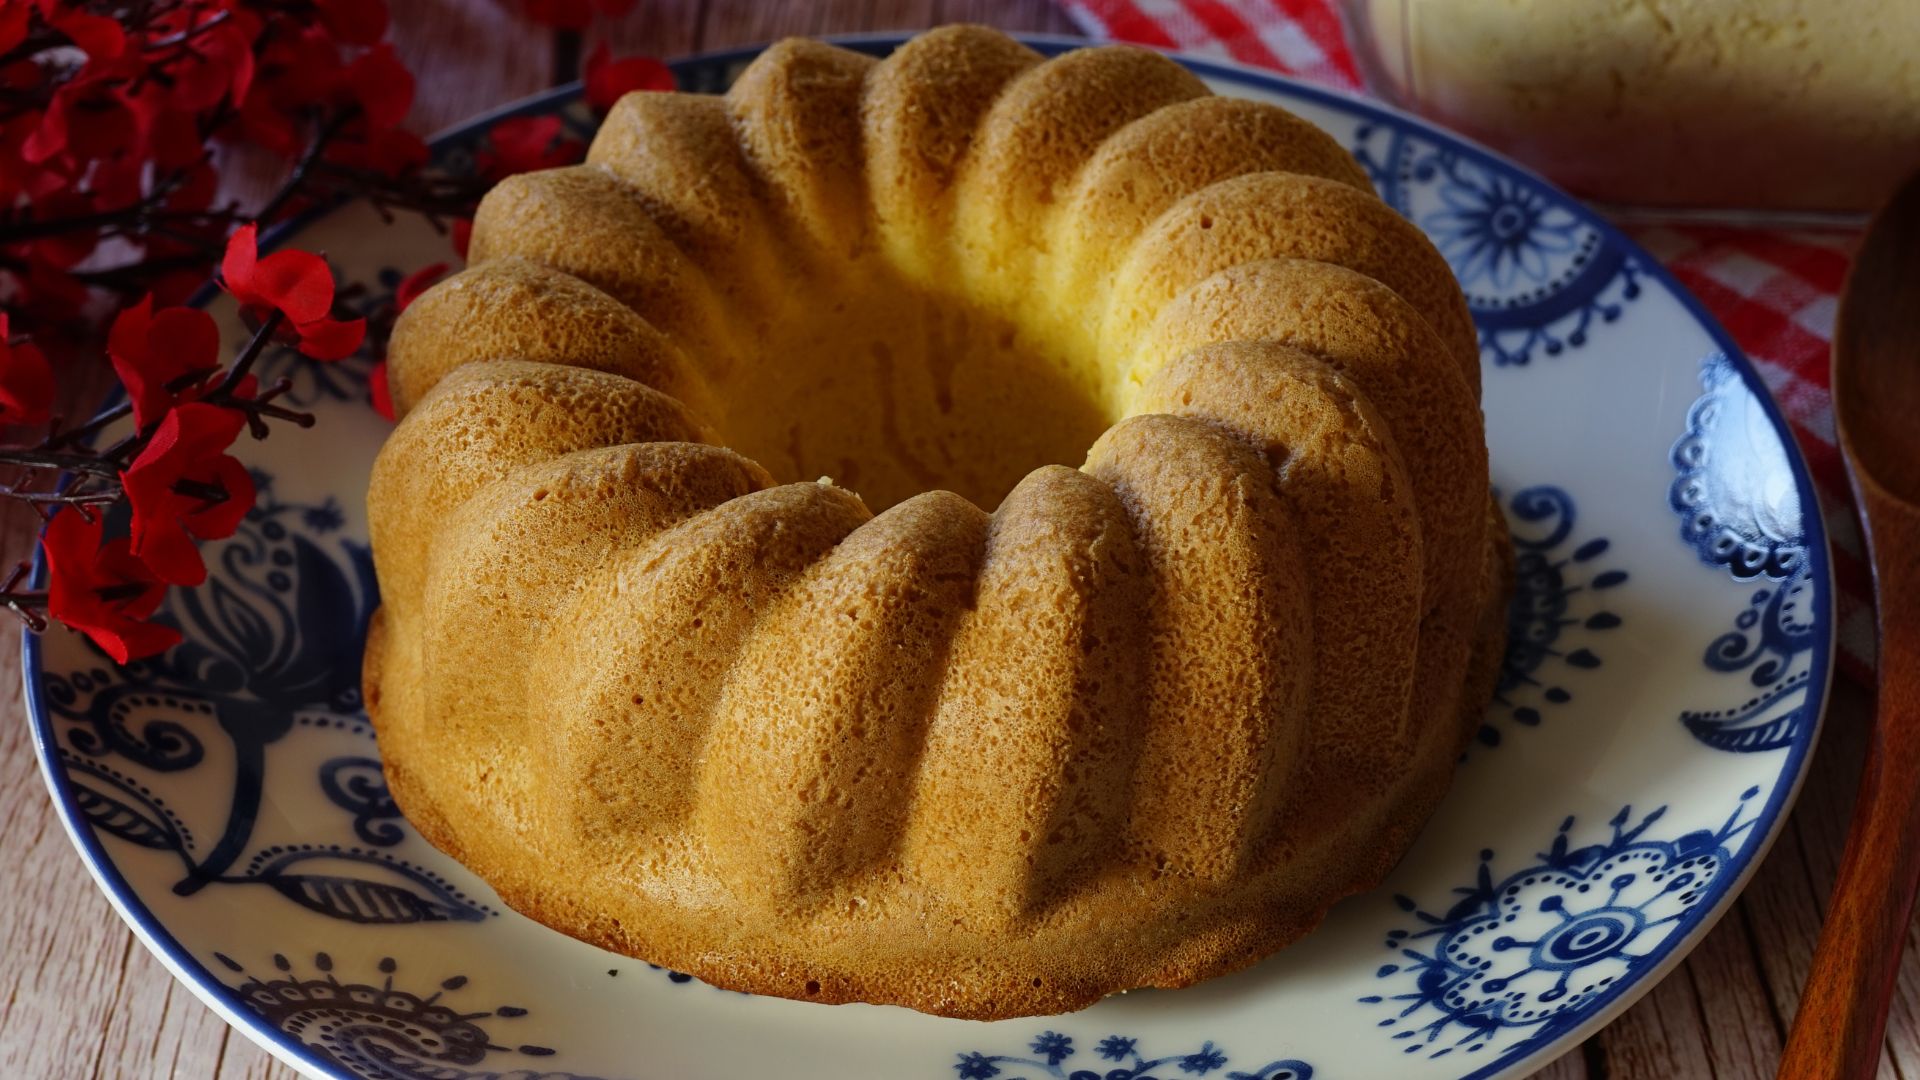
[{"x1": 1352, "y1": 123, "x2": 1644, "y2": 367}]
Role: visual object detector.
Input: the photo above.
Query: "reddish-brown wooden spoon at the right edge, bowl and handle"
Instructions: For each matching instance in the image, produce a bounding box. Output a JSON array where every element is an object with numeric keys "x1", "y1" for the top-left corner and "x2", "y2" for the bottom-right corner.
[{"x1": 1780, "y1": 175, "x2": 1920, "y2": 1080}]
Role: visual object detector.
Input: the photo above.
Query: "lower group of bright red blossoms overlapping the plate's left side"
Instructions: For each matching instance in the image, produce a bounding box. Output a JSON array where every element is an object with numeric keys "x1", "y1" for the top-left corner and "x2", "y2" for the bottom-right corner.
[{"x1": 0, "y1": 225, "x2": 367, "y2": 663}]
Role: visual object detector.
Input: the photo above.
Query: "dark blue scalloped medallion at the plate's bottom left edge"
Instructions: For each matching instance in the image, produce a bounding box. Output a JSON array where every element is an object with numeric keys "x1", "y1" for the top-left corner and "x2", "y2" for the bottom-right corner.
[{"x1": 213, "y1": 953, "x2": 618, "y2": 1080}]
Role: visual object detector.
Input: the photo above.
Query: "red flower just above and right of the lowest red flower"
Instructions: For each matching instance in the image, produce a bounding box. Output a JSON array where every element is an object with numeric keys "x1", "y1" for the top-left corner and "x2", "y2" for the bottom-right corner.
[{"x1": 121, "y1": 402, "x2": 253, "y2": 584}]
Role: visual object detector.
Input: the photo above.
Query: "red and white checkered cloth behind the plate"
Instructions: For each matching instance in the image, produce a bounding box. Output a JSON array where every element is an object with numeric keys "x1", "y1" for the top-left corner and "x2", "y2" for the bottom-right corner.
[{"x1": 1062, "y1": 0, "x2": 1874, "y2": 682}]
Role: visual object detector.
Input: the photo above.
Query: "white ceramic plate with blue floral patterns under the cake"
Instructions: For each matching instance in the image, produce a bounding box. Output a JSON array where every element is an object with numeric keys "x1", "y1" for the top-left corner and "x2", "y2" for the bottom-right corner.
[{"x1": 25, "y1": 38, "x2": 1834, "y2": 1080}]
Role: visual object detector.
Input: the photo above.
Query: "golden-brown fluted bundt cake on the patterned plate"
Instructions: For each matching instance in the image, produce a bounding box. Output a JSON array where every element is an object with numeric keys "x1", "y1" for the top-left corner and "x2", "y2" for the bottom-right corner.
[{"x1": 365, "y1": 27, "x2": 1509, "y2": 1019}]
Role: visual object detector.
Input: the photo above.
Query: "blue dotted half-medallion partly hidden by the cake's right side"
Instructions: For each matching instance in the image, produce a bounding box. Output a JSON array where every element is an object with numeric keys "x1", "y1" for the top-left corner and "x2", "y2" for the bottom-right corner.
[{"x1": 1478, "y1": 486, "x2": 1626, "y2": 746}]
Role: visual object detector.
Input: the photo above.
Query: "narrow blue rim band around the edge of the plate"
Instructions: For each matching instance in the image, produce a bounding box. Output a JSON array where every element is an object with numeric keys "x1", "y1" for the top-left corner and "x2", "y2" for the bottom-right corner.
[{"x1": 21, "y1": 31, "x2": 1836, "y2": 1080}]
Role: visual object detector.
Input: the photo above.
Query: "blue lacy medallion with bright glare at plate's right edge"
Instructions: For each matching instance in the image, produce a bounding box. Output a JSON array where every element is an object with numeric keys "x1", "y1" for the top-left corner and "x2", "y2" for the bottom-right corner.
[{"x1": 1668, "y1": 352, "x2": 1812, "y2": 578}]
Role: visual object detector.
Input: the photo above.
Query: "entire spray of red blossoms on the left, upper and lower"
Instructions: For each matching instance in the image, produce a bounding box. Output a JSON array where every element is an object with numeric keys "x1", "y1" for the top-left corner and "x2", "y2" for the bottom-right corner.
[{"x1": 0, "y1": 0, "x2": 672, "y2": 663}]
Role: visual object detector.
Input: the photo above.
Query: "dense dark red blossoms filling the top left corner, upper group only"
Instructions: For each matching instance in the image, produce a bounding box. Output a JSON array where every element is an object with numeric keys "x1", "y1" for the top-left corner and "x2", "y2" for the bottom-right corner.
[{"x1": 0, "y1": 0, "x2": 670, "y2": 334}]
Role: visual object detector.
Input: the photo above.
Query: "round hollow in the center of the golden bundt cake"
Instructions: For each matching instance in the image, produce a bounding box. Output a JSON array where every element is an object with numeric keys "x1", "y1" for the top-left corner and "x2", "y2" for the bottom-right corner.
[{"x1": 716, "y1": 281, "x2": 1110, "y2": 513}]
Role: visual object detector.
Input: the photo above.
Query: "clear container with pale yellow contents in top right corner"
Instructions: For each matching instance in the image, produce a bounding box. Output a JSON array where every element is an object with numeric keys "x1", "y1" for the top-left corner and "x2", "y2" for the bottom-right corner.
[{"x1": 1344, "y1": 0, "x2": 1920, "y2": 209}]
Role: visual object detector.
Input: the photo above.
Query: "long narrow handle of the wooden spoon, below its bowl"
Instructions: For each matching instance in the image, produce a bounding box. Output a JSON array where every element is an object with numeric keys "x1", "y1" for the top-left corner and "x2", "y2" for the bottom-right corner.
[{"x1": 1780, "y1": 492, "x2": 1920, "y2": 1080}]
